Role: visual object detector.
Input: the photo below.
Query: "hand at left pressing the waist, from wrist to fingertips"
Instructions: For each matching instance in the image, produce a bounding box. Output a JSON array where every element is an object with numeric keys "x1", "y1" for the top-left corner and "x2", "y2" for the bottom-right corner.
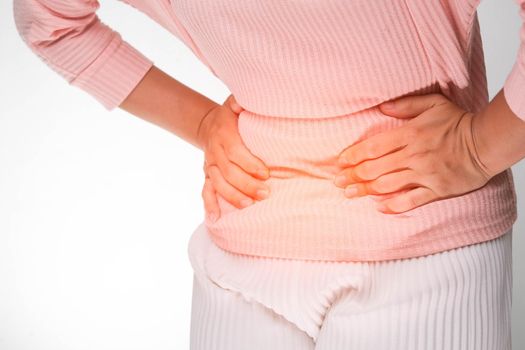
[{"x1": 198, "y1": 95, "x2": 270, "y2": 221}]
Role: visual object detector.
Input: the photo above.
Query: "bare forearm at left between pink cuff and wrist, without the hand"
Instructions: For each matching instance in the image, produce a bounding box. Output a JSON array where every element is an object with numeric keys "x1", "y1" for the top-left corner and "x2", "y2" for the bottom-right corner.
[{"x1": 119, "y1": 66, "x2": 218, "y2": 149}]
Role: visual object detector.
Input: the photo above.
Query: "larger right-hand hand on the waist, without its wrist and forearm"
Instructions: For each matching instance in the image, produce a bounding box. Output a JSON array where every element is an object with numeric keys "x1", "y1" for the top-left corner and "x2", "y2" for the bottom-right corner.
[{"x1": 334, "y1": 93, "x2": 496, "y2": 213}]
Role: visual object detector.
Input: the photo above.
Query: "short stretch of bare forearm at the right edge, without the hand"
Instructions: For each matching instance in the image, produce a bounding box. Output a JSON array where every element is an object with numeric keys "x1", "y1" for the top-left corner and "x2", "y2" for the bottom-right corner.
[{"x1": 473, "y1": 89, "x2": 525, "y2": 175}]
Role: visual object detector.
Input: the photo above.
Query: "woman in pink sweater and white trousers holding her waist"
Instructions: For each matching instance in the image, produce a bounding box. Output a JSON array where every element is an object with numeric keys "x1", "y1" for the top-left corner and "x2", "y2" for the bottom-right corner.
[{"x1": 14, "y1": 0, "x2": 525, "y2": 350}]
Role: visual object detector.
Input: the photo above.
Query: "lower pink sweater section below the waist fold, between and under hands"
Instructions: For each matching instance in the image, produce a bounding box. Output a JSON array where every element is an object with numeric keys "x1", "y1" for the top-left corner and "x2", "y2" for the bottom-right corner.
[{"x1": 205, "y1": 108, "x2": 517, "y2": 261}]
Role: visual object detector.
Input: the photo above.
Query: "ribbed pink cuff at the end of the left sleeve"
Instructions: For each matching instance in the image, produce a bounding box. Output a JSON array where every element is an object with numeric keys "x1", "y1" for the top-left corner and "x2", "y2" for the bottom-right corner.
[{"x1": 70, "y1": 34, "x2": 153, "y2": 111}]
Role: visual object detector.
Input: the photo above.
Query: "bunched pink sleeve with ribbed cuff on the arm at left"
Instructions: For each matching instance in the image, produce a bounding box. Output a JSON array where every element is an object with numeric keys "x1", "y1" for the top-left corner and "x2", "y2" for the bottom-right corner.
[{"x1": 13, "y1": 0, "x2": 153, "y2": 110}]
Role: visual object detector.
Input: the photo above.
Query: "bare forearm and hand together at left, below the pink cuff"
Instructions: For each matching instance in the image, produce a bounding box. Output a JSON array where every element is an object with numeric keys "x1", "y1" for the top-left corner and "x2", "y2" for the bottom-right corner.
[{"x1": 119, "y1": 66, "x2": 269, "y2": 218}]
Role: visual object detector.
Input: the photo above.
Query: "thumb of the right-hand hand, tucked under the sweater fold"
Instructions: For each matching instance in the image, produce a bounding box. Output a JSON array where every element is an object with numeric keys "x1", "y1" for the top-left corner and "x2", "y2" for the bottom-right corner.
[{"x1": 379, "y1": 93, "x2": 446, "y2": 118}]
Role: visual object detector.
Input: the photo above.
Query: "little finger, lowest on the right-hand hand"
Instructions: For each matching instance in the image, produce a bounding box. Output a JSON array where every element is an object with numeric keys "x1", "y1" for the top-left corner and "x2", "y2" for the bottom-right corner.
[{"x1": 376, "y1": 187, "x2": 437, "y2": 214}]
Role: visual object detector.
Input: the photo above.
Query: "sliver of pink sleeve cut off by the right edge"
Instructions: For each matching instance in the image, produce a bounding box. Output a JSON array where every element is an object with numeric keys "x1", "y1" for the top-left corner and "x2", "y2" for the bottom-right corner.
[{"x1": 503, "y1": 0, "x2": 525, "y2": 121}]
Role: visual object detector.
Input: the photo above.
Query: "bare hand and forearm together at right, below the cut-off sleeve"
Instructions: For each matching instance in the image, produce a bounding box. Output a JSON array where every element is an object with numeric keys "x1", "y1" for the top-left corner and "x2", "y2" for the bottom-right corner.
[{"x1": 334, "y1": 90, "x2": 525, "y2": 213}]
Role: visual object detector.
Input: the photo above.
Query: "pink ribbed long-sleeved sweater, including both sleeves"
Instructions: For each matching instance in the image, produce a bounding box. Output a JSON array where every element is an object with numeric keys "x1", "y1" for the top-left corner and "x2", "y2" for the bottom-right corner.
[{"x1": 14, "y1": 0, "x2": 525, "y2": 261}]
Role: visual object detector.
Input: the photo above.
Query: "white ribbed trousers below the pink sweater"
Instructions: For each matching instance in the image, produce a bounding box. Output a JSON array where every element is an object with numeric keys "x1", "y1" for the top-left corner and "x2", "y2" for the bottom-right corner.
[{"x1": 189, "y1": 226, "x2": 512, "y2": 350}]
